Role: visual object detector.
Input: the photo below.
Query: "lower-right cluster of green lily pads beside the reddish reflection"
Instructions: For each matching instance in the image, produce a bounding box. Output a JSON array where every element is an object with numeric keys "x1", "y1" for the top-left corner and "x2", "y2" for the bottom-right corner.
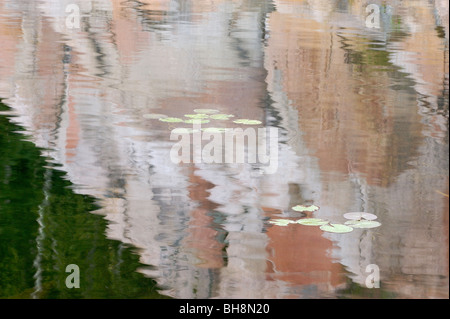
[{"x1": 269, "y1": 205, "x2": 381, "y2": 233}]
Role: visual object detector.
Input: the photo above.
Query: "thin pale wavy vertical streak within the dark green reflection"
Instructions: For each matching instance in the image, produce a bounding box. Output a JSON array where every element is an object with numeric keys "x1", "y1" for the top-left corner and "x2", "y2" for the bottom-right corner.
[{"x1": 31, "y1": 168, "x2": 52, "y2": 299}]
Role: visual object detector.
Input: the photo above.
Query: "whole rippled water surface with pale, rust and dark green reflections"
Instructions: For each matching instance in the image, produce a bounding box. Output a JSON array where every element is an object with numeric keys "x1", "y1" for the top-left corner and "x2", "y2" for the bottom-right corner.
[{"x1": 0, "y1": 0, "x2": 449, "y2": 298}]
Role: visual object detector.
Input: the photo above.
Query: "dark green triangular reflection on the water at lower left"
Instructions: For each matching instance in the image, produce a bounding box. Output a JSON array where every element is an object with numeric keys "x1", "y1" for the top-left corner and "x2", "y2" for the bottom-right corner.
[{"x1": 0, "y1": 101, "x2": 168, "y2": 298}]
